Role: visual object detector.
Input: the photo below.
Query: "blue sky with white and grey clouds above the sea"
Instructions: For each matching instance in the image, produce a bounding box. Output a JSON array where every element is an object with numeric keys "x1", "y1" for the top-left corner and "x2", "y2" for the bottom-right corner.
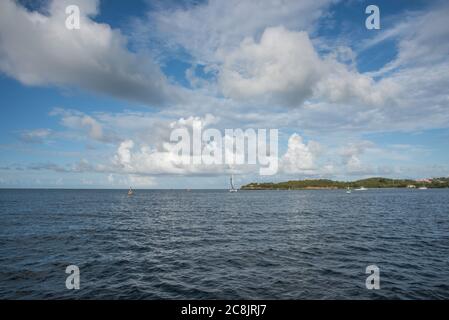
[{"x1": 0, "y1": 0, "x2": 449, "y2": 189}]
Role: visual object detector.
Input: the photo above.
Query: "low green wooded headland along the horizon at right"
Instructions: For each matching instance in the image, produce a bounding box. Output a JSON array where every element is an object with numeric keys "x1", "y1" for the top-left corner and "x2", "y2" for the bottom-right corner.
[{"x1": 241, "y1": 178, "x2": 449, "y2": 190}]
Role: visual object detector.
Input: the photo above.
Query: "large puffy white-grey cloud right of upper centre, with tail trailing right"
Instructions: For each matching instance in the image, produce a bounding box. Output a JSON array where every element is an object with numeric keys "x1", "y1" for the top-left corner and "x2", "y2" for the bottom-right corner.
[{"x1": 218, "y1": 27, "x2": 399, "y2": 106}]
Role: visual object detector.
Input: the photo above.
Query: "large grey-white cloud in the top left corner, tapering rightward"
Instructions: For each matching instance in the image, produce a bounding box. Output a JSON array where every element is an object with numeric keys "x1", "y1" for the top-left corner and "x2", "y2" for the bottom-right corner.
[{"x1": 0, "y1": 0, "x2": 183, "y2": 106}]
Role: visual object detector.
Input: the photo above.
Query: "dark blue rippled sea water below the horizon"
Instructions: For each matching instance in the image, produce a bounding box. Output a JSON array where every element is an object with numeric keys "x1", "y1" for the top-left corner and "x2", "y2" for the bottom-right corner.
[{"x1": 0, "y1": 189, "x2": 449, "y2": 299}]
